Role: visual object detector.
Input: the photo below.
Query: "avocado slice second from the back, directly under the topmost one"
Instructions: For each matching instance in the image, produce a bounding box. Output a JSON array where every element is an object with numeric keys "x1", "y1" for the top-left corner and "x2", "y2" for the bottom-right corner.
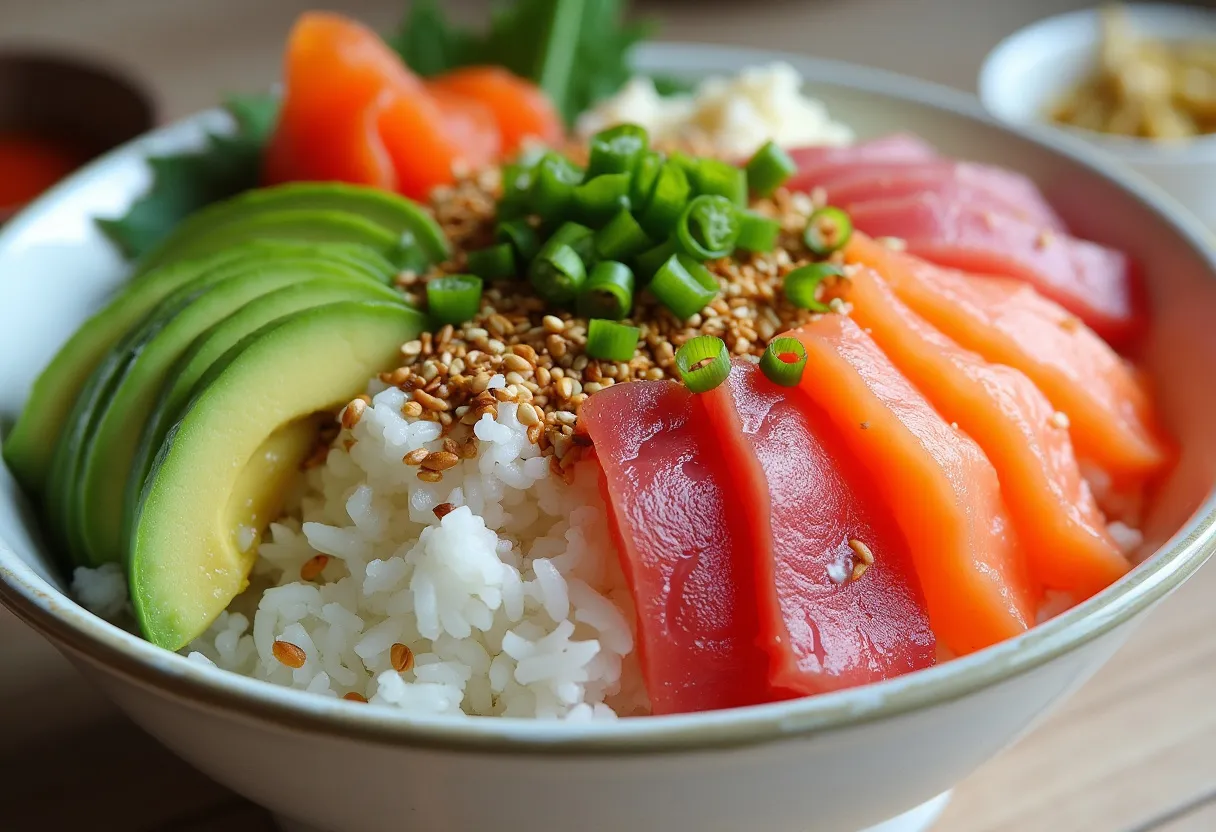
[{"x1": 139, "y1": 208, "x2": 420, "y2": 274}]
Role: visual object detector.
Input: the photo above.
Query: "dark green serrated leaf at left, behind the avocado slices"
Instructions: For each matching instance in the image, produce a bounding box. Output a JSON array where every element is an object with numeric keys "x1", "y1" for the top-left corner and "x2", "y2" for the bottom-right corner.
[{"x1": 96, "y1": 95, "x2": 278, "y2": 259}]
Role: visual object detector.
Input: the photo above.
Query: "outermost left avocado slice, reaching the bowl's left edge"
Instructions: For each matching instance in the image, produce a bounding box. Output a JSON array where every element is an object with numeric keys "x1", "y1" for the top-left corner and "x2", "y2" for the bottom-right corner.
[{"x1": 0, "y1": 241, "x2": 396, "y2": 497}]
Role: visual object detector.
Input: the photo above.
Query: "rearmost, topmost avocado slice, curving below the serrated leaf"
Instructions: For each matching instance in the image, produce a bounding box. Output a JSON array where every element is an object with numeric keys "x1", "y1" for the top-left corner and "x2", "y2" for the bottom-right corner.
[{"x1": 143, "y1": 182, "x2": 451, "y2": 268}]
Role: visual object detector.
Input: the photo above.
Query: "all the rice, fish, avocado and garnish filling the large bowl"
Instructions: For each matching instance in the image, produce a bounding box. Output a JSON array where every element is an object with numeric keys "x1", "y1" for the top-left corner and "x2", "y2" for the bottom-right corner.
[{"x1": 4, "y1": 4, "x2": 1175, "y2": 720}]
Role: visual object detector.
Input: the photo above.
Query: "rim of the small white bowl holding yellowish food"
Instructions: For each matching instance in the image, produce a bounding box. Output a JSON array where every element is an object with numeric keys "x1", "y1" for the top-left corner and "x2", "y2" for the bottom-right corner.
[{"x1": 975, "y1": 2, "x2": 1216, "y2": 164}]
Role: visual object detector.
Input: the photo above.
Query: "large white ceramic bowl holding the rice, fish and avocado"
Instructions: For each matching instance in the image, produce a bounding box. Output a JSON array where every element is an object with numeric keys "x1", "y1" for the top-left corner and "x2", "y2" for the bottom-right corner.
[{"x1": 0, "y1": 45, "x2": 1216, "y2": 832}]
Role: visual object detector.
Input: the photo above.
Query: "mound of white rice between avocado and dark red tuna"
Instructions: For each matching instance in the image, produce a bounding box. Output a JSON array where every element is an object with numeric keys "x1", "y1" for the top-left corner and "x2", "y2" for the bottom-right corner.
[{"x1": 186, "y1": 376, "x2": 647, "y2": 719}]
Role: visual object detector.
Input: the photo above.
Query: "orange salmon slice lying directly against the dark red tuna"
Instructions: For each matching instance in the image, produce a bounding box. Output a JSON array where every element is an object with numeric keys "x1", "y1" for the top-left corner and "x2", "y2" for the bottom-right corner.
[{"x1": 789, "y1": 315, "x2": 1040, "y2": 654}]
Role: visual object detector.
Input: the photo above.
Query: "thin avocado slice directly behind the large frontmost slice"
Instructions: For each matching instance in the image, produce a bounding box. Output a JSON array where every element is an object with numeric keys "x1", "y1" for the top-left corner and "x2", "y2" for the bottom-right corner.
[{"x1": 123, "y1": 277, "x2": 401, "y2": 540}]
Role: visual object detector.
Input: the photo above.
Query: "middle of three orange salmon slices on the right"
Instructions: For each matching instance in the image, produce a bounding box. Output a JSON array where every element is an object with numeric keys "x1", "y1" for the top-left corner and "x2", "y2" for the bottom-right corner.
[{"x1": 837, "y1": 269, "x2": 1131, "y2": 601}]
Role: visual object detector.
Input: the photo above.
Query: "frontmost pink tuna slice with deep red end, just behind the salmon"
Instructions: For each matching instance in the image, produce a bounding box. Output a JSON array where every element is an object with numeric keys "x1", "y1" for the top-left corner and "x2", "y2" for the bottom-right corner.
[{"x1": 850, "y1": 195, "x2": 1145, "y2": 344}]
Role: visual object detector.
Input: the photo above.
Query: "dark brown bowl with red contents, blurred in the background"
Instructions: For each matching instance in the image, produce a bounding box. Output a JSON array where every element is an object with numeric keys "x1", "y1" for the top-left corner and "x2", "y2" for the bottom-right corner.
[{"x1": 0, "y1": 50, "x2": 156, "y2": 221}]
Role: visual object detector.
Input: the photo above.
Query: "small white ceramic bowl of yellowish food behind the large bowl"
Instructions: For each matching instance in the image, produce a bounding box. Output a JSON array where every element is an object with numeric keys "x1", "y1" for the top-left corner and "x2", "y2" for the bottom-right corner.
[{"x1": 978, "y1": 4, "x2": 1216, "y2": 226}]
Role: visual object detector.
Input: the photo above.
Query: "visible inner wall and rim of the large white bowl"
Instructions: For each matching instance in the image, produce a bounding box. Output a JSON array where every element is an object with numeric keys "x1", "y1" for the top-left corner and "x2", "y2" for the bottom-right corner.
[{"x1": 0, "y1": 45, "x2": 1216, "y2": 747}]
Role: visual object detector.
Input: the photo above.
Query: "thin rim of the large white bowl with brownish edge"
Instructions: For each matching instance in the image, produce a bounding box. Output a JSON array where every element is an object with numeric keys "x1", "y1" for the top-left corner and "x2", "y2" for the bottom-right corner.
[{"x1": 0, "y1": 43, "x2": 1216, "y2": 757}]
